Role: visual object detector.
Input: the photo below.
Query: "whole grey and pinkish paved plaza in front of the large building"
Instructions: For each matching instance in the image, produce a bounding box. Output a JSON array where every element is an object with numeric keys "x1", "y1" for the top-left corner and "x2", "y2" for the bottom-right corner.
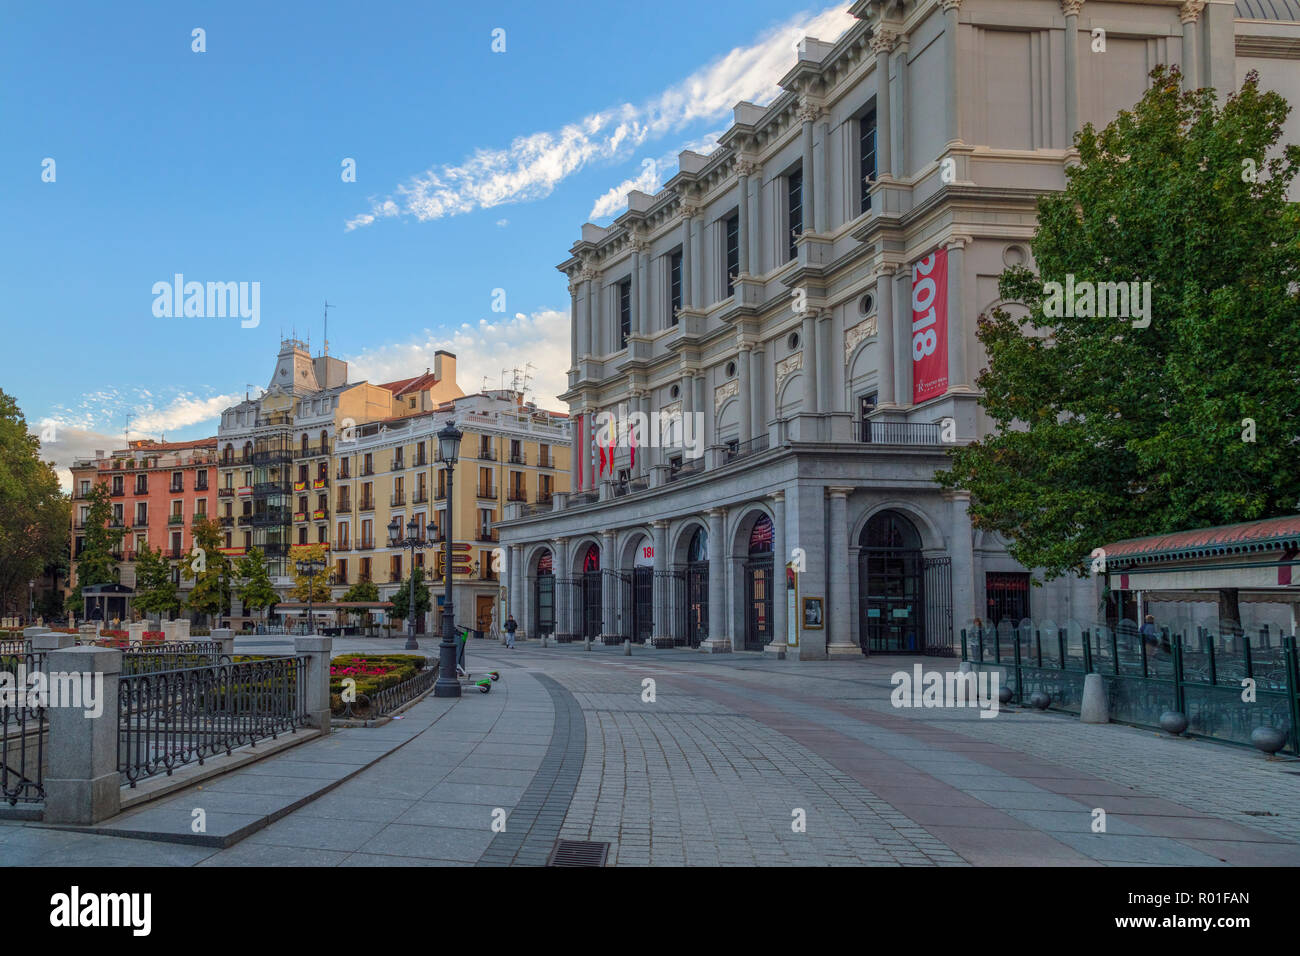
[{"x1": 0, "y1": 639, "x2": 1300, "y2": 866}]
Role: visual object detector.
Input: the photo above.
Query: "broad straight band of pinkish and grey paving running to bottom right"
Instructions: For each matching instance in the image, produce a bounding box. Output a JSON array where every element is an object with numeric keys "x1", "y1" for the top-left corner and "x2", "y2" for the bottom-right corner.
[{"x1": 655, "y1": 660, "x2": 1300, "y2": 866}]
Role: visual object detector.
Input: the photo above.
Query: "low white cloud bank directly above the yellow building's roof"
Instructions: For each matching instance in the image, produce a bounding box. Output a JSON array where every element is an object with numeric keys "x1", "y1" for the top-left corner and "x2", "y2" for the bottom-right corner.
[{"x1": 347, "y1": 310, "x2": 571, "y2": 411}]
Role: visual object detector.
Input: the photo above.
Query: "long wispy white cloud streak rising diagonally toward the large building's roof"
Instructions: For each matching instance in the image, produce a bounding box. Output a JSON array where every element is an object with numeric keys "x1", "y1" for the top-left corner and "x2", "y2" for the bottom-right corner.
[{"x1": 347, "y1": 4, "x2": 853, "y2": 230}]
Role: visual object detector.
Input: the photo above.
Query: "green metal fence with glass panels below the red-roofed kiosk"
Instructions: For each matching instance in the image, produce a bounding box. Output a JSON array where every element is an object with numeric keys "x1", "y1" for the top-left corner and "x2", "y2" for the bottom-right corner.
[{"x1": 962, "y1": 622, "x2": 1300, "y2": 754}]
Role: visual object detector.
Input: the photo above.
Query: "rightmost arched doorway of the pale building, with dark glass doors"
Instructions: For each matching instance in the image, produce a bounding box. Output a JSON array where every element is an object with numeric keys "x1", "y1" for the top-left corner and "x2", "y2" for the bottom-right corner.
[{"x1": 858, "y1": 511, "x2": 926, "y2": 654}]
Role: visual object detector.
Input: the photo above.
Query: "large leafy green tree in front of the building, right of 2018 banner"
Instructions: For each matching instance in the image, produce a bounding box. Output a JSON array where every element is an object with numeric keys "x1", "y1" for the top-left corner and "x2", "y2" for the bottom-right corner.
[{"x1": 937, "y1": 68, "x2": 1300, "y2": 579}]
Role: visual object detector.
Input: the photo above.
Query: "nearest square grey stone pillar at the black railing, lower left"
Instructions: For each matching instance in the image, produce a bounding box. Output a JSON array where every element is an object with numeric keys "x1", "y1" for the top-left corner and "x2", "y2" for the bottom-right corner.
[{"x1": 44, "y1": 647, "x2": 122, "y2": 825}]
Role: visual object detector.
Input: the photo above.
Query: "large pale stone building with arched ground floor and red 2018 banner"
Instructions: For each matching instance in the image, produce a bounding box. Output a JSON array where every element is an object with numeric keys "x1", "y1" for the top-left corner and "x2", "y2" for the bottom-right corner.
[{"x1": 498, "y1": 0, "x2": 1300, "y2": 659}]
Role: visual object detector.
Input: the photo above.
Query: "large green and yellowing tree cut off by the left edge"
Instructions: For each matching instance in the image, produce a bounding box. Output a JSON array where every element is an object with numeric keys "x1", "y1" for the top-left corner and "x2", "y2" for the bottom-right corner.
[{"x1": 0, "y1": 390, "x2": 72, "y2": 611}]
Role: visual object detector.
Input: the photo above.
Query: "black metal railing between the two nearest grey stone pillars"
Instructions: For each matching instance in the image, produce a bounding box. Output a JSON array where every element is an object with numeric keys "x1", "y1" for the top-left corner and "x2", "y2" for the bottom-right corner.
[{"x1": 117, "y1": 657, "x2": 307, "y2": 787}]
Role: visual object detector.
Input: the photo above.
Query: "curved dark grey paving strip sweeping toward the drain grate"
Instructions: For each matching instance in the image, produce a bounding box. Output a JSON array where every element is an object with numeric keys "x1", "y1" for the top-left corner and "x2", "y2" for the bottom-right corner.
[{"x1": 478, "y1": 674, "x2": 586, "y2": 866}]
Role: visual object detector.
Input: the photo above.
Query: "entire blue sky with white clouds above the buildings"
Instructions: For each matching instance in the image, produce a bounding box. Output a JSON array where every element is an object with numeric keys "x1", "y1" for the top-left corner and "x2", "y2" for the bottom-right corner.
[{"x1": 0, "y1": 0, "x2": 850, "y2": 478}]
